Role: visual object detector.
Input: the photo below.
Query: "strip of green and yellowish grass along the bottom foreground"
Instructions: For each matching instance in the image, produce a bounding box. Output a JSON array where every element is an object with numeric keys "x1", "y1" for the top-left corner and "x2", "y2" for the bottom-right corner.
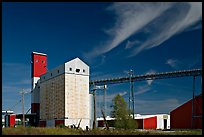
[{"x1": 2, "y1": 127, "x2": 202, "y2": 135}]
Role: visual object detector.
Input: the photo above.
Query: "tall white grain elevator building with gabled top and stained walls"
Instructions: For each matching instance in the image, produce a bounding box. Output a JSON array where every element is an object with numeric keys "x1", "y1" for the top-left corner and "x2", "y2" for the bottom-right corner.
[{"x1": 31, "y1": 52, "x2": 93, "y2": 129}]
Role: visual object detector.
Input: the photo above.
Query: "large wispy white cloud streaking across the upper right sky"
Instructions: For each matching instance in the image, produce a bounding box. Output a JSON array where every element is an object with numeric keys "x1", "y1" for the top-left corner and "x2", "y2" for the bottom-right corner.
[{"x1": 87, "y1": 2, "x2": 202, "y2": 57}]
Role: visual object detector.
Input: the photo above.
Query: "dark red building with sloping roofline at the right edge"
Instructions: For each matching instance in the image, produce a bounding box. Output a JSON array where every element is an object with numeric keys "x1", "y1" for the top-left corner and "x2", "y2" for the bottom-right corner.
[{"x1": 170, "y1": 95, "x2": 202, "y2": 129}]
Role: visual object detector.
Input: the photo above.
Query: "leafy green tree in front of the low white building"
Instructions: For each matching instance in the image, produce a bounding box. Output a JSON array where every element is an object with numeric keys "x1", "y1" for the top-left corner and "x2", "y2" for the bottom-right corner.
[{"x1": 111, "y1": 94, "x2": 137, "y2": 129}]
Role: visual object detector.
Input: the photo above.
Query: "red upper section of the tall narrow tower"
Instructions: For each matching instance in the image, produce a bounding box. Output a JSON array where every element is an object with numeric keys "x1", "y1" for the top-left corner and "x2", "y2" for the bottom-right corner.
[{"x1": 32, "y1": 53, "x2": 47, "y2": 77}]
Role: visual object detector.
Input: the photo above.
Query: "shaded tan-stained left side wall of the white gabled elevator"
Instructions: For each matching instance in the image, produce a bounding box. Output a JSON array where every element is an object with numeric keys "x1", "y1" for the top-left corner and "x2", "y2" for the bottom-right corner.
[{"x1": 40, "y1": 74, "x2": 65, "y2": 120}]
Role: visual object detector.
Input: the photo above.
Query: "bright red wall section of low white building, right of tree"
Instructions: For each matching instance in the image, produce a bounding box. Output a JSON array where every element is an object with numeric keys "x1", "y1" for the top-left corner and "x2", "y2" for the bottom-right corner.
[{"x1": 143, "y1": 116, "x2": 157, "y2": 129}]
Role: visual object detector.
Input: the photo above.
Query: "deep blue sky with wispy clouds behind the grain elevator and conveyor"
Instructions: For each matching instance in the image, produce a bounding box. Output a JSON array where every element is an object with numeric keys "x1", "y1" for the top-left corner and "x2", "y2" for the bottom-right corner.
[{"x1": 2, "y1": 2, "x2": 202, "y2": 116}]
